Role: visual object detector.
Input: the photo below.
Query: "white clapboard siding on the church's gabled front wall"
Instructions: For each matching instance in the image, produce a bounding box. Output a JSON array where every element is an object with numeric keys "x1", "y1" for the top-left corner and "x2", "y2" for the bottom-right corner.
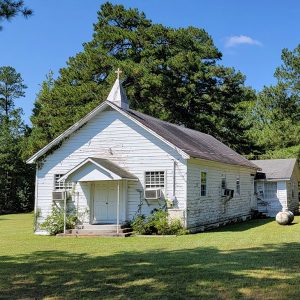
[{"x1": 36, "y1": 109, "x2": 186, "y2": 223}]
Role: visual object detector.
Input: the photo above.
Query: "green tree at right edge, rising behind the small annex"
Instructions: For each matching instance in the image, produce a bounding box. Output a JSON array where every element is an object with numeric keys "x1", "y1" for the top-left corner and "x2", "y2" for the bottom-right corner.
[{"x1": 249, "y1": 45, "x2": 300, "y2": 157}]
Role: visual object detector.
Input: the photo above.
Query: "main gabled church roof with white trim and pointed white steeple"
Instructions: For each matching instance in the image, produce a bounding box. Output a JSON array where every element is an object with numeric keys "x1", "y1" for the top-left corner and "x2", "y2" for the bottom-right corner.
[{"x1": 27, "y1": 79, "x2": 258, "y2": 169}]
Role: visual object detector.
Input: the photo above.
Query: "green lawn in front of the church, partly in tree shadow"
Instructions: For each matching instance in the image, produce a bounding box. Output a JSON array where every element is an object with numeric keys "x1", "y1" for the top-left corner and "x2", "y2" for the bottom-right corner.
[{"x1": 0, "y1": 214, "x2": 300, "y2": 299}]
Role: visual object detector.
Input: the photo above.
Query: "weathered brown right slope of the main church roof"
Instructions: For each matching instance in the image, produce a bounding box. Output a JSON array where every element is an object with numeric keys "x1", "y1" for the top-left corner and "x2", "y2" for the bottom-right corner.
[{"x1": 126, "y1": 109, "x2": 258, "y2": 169}]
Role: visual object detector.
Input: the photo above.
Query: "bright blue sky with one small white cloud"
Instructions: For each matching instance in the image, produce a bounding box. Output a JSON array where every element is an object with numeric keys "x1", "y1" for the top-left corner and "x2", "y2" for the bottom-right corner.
[{"x1": 0, "y1": 0, "x2": 300, "y2": 123}]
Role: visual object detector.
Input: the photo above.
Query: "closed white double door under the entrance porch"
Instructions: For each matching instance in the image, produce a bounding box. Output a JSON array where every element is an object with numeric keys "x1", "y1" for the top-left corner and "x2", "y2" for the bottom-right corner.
[{"x1": 94, "y1": 181, "x2": 118, "y2": 223}]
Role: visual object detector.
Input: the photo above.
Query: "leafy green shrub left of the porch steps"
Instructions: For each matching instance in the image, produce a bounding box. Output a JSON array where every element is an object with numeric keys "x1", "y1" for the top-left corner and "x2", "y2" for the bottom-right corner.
[{"x1": 41, "y1": 206, "x2": 77, "y2": 235}]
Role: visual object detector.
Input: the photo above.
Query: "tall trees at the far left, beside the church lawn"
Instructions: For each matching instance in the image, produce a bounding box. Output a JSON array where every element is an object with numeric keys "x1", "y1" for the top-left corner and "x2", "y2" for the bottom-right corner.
[{"x1": 0, "y1": 67, "x2": 34, "y2": 213}]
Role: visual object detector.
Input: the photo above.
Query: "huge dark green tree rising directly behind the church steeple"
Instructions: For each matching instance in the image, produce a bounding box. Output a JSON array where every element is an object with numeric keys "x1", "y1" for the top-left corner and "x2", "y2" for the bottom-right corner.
[{"x1": 26, "y1": 3, "x2": 255, "y2": 155}]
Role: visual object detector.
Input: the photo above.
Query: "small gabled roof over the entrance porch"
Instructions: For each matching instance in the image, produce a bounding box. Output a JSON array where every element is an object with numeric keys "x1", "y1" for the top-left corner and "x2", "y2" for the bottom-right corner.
[{"x1": 59, "y1": 157, "x2": 137, "y2": 181}]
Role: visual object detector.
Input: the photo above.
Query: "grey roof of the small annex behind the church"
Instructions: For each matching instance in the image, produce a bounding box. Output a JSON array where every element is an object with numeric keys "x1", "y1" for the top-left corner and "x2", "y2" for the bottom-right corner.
[{"x1": 252, "y1": 158, "x2": 297, "y2": 180}]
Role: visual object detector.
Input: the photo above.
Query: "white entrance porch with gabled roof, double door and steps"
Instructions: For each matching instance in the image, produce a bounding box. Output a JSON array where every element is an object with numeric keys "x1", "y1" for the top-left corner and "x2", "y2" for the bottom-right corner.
[{"x1": 60, "y1": 157, "x2": 138, "y2": 234}]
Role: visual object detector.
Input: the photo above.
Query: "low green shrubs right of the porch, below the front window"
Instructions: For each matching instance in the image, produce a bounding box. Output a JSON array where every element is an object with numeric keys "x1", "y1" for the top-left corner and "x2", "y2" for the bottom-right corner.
[{"x1": 131, "y1": 209, "x2": 187, "y2": 235}]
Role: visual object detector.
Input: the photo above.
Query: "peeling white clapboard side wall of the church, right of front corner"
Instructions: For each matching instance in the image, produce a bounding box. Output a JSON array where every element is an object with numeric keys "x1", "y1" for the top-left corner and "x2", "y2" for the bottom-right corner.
[{"x1": 187, "y1": 159, "x2": 256, "y2": 228}]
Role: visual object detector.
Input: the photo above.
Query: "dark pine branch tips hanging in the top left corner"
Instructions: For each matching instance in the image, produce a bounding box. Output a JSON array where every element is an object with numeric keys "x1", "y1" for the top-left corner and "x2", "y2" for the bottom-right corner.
[{"x1": 0, "y1": 0, "x2": 33, "y2": 30}]
